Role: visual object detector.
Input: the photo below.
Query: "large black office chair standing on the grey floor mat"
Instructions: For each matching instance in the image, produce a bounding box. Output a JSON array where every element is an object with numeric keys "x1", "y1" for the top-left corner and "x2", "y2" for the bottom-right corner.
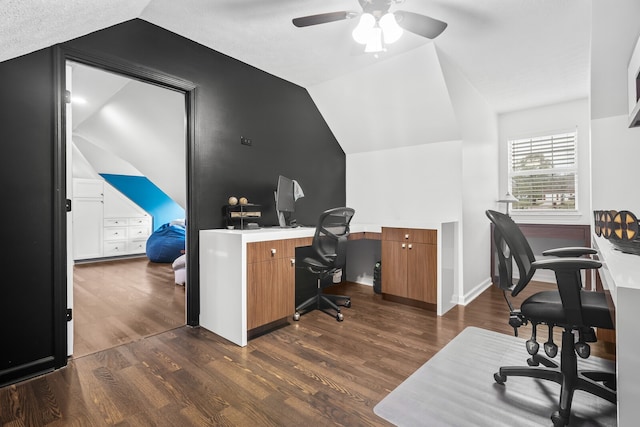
[{"x1": 486, "y1": 210, "x2": 616, "y2": 426}]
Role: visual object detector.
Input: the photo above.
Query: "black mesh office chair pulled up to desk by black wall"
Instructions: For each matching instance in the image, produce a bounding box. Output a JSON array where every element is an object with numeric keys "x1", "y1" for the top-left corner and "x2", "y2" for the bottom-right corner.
[{"x1": 293, "y1": 207, "x2": 355, "y2": 322}]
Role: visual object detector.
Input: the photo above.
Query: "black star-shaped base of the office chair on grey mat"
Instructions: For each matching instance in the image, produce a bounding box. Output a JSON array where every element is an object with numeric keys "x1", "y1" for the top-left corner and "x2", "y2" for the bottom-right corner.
[{"x1": 493, "y1": 329, "x2": 616, "y2": 426}]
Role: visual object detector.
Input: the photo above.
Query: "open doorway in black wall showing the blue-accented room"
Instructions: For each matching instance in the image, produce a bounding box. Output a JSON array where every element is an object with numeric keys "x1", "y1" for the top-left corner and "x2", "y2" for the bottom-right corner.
[{"x1": 65, "y1": 59, "x2": 189, "y2": 357}]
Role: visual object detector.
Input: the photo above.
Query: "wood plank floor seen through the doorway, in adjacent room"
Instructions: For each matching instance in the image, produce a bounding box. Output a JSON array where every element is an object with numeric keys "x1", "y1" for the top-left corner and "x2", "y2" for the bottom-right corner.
[{"x1": 73, "y1": 258, "x2": 185, "y2": 358}]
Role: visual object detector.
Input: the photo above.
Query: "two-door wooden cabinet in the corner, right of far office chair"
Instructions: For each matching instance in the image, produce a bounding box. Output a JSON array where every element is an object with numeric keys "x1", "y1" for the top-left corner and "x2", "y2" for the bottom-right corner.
[{"x1": 382, "y1": 227, "x2": 438, "y2": 304}]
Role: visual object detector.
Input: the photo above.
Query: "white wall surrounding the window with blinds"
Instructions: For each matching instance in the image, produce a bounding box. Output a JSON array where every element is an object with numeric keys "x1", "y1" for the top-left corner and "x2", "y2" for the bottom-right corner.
[{"x1": 498, "y1": 98, "x2": 591, "y2": 224}]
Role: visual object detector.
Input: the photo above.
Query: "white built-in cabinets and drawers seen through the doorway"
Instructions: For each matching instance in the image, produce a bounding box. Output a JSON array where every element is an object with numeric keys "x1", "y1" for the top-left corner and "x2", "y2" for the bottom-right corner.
[{"x1": 72, "y1": 178, "x2": 151, "y2": 260}]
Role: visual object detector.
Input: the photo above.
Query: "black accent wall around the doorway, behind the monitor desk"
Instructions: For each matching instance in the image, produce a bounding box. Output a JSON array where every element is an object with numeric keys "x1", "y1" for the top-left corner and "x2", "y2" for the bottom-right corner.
[{"x1": 0, "y1": 19, "x2": 345, "y2": 385}]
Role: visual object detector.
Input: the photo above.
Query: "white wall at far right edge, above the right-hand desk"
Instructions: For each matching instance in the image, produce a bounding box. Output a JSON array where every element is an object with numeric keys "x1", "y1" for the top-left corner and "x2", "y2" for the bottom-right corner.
[{"x1": 591, "y1": 0, "x2": 640, "y2": 215}]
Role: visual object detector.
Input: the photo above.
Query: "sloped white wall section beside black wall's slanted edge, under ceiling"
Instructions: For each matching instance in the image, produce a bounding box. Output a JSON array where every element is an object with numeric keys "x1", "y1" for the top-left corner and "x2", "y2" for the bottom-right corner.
[{"x1": 307, "y1": 43, "x2": 460, "y2": 154}]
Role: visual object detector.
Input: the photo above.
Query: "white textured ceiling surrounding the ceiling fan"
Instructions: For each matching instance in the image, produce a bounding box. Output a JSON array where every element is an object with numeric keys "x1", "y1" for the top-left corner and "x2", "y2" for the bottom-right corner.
[{"x1": 0, "y1": 0, "x2": 591, "y2": 112}]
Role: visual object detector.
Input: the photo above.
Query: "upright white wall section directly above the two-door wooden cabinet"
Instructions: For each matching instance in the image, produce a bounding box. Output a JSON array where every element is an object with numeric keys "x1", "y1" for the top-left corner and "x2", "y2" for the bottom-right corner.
[{"x1": 346, "y1": 141, "x2": 462, "y2": 227}]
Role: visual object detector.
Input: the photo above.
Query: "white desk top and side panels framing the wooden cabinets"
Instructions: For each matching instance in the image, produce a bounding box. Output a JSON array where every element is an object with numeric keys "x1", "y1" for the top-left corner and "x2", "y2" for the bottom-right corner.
[{"x1": 199, "y1": 223, "x2": 458, "y2": 346}]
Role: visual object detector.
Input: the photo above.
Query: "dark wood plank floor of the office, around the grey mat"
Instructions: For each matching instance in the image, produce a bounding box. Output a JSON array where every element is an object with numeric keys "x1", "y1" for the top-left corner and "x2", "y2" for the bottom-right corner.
[{"x1": 0, "y1": 284, "x2": 616, "y2": 426}]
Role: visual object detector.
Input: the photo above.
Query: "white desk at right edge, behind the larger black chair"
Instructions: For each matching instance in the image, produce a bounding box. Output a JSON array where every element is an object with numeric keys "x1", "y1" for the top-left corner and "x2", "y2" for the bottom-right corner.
[{"x1": 593, "y1": 236, "x2": 640, "y2": 427}]
